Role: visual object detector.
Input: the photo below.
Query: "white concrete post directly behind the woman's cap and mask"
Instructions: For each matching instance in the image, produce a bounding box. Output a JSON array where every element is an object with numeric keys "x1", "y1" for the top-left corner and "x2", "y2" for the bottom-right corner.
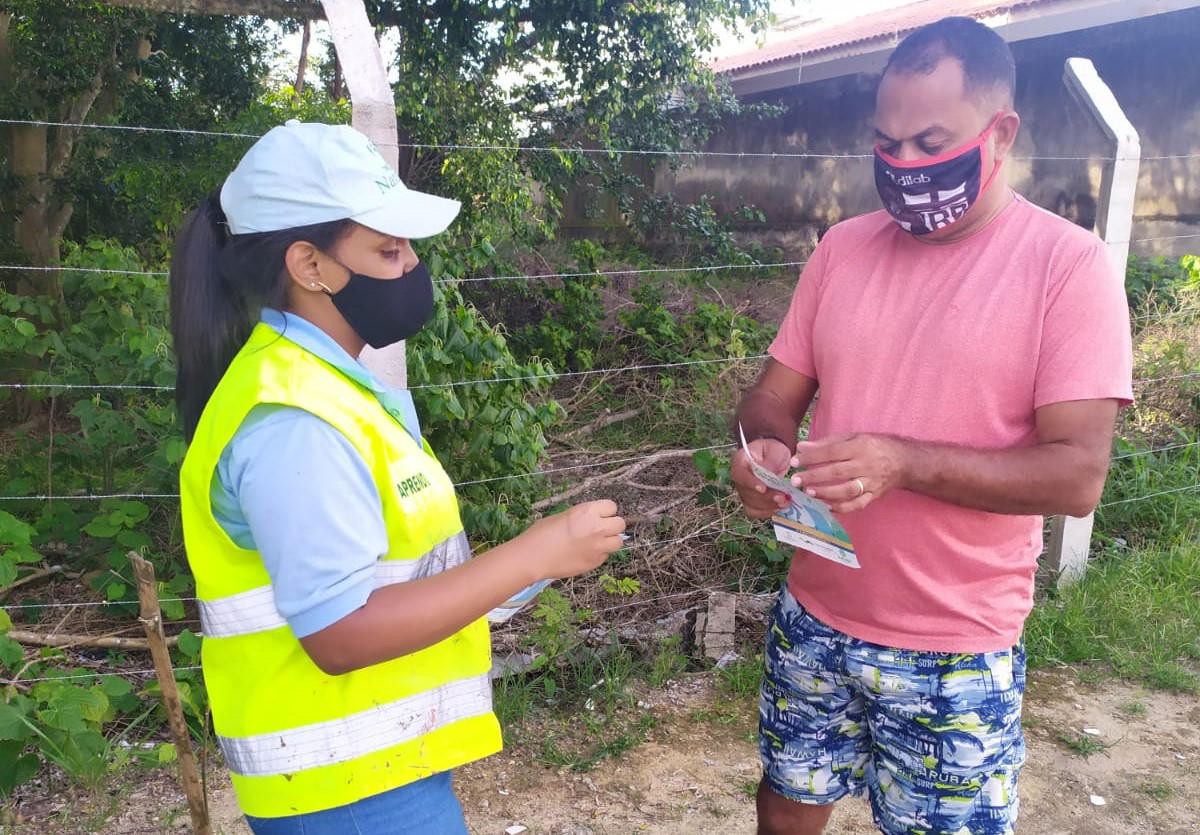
[{"x1": 320, "y1": 0, "x2": 408, "y2": 388}]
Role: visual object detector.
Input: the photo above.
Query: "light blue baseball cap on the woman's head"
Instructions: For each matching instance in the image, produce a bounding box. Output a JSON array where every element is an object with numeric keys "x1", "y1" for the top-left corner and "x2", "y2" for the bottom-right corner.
[{"x1": 221, "y1": 119, "x2": 460, "y2": 243}]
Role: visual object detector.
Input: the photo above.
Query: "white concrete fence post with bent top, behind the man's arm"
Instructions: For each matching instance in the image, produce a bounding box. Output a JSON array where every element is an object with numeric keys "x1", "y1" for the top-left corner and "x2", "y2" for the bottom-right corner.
[{"x1": 1048, "y1": 58, "x2": 1141, "y2": 587}]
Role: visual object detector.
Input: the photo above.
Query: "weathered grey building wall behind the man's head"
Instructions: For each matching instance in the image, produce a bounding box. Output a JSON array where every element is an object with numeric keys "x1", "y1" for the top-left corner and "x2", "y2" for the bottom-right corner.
[{"x1": 655, "y1": 10, "x2": 1200, "y2": 257}]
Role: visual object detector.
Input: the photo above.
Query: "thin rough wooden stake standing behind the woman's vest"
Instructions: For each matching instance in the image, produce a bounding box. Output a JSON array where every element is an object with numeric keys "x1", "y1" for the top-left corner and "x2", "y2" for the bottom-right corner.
[{"x1": 130, "y1": 551, "x2": 212, "y2": 835}]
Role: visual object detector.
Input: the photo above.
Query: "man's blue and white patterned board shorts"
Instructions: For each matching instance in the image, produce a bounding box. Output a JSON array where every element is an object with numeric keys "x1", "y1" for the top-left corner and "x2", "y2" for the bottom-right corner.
[{"x1": 758, "y1": 588, "x2": 1025, "y2": 835}]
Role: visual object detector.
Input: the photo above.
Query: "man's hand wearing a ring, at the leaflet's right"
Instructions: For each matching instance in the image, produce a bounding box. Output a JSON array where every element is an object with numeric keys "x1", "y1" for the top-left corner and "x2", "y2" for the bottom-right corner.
[{"x1": 791, "y1": 434, "x2": 907, "y2": 513}]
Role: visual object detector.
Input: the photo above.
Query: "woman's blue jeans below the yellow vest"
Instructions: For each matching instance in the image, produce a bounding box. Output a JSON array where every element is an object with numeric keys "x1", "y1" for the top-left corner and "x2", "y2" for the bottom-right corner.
[{"x1": 246, "y1": 771, "x2": 467, "y2": 835}]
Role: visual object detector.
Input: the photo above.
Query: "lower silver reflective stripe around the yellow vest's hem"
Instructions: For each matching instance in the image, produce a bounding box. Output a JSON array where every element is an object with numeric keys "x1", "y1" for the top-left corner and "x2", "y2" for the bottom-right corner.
[{"x1": 220, "y1": 673, "x2": 492, "y2": 777}]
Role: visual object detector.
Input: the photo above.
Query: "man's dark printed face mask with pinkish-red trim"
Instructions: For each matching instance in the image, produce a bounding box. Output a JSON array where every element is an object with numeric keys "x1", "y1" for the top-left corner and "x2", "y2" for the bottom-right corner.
[{"x1": 875, "y1": 114, "x2": 1003, "y2": 235}]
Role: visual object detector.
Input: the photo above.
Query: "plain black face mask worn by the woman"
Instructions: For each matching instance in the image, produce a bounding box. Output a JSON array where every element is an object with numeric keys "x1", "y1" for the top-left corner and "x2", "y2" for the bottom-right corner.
[{"x1": 325, "y1": 262, "x2": 433, "y2": 348}]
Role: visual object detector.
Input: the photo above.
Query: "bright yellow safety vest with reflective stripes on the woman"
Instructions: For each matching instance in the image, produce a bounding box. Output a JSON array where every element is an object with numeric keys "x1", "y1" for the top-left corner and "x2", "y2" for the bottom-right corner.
[{"x1": 180, "y1": 324, "x2": 500, "y2": 817}]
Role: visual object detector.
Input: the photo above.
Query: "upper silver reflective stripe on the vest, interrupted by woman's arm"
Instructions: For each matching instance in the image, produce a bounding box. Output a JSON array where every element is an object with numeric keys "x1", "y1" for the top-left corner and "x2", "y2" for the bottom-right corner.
[{"x1": 200, "y1": 533, "x2": 470, "y2": 638}]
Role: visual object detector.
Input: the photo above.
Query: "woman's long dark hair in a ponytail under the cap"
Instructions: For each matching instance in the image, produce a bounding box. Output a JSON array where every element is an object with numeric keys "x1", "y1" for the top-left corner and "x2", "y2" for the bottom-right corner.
[{"x1": 170, "y1": 194, "x2": 354, "y2": 440}]
